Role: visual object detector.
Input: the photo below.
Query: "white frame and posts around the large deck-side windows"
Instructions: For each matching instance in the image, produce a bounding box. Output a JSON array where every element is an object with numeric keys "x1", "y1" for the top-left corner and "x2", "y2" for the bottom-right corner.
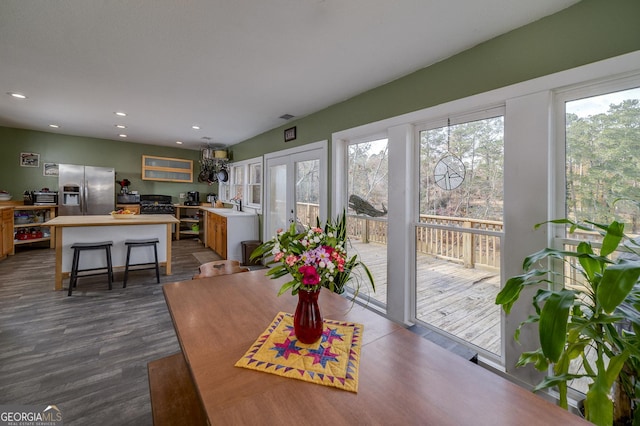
[{"x1": 331, "y1": 51, "x2": 640, "y2": 385}]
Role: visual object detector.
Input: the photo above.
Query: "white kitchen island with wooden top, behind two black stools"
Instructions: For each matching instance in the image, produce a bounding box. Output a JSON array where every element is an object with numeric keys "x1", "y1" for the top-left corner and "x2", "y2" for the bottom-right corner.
[{"x1": 45, "y1": 214, "x2": 179, "y2": 290}]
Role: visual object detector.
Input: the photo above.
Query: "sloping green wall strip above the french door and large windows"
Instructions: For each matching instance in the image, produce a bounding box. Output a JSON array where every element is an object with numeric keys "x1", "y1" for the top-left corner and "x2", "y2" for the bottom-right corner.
[{"x1": 232, "y1": 0, "x2": 640, "y2": 160}]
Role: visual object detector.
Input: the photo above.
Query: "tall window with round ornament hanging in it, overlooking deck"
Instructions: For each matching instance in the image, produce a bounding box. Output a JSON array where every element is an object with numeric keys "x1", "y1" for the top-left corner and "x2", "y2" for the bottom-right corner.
[{"x1": 414, "y1": 108, "x2": 504, "y2": 355}]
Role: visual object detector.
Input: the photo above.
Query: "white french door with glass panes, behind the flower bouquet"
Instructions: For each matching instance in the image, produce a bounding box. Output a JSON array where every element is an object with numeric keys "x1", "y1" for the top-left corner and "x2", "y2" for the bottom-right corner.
[{"x1": 263, "y1": 141, "x2": 327, "y2": 241}]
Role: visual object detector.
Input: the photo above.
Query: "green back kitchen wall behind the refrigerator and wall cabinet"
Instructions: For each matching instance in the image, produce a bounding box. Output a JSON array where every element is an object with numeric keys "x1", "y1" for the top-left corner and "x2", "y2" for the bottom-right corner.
[{"x1": 0, "y1": 127, "x2": 218, "y2": 203}]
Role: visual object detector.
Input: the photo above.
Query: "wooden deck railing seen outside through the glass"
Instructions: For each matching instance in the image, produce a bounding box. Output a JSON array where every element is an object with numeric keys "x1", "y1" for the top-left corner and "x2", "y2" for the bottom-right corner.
[{"x1": 297, "y1": 203, "x2": 503, "y2": 270}]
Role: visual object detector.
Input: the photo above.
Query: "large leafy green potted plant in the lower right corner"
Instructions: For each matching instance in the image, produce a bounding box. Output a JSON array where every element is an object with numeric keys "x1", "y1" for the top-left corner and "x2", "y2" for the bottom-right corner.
[{"x1": 496, "y1": 219, "x2": 640, "y2": 425}]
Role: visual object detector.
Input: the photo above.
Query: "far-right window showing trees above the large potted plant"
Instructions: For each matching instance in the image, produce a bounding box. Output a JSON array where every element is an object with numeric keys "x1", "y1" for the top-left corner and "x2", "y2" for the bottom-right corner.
[{"x1": 565, "y1": 88, "x2": 640, "y2": 234}]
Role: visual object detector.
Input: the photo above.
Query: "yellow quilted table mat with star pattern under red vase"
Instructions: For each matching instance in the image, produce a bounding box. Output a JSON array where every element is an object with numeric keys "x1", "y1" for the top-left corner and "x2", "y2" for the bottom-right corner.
[{"x1": 235, "y1": 312, "x2": 364, "y2": 392}]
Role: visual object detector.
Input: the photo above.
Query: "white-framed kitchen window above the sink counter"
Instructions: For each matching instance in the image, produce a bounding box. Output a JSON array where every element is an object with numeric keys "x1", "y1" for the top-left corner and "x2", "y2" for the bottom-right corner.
[{"x1": 219, "y1": 158, "x2": 262, "y2": 209}]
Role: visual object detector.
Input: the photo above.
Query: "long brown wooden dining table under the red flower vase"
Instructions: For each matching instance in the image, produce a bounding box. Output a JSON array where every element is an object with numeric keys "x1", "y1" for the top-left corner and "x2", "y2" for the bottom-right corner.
[{"x1": 163, "y1": 270, "x2": 588, "y2": 426}]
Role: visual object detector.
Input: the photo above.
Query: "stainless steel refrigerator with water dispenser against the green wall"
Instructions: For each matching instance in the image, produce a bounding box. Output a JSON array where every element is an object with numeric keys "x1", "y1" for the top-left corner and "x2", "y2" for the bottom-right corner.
[{"x1": 58, "y1": 164, "x2": 116, "y2": 216}]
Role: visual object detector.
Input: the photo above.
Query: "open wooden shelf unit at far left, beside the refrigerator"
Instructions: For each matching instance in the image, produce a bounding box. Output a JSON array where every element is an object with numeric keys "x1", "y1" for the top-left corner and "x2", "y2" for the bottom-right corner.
[{"x1": 13, "y1": 206, "x2": 56, "y2": 248}]
